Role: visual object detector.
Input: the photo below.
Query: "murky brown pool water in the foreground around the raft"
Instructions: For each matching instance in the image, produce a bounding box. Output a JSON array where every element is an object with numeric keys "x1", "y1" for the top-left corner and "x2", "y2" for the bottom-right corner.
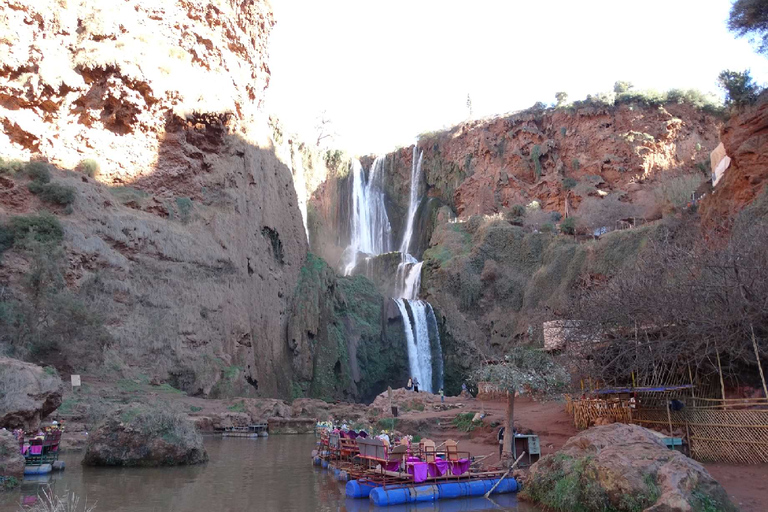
[{"x1": 0, "y1": 436, "x2": 535, "y2": 512}]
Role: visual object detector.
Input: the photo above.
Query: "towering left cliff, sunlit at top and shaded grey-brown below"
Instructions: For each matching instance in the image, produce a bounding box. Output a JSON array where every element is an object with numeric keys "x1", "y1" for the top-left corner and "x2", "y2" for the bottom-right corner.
[{"x1": 0, "y1": 0, "x2": 316, "y2": 395}]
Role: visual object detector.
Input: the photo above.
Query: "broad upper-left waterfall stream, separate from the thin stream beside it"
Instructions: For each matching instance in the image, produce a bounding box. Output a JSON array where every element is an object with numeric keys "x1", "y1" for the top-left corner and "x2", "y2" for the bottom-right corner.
[{"x1": 344, "y1": 157, "x2": 392, "y2": 275}]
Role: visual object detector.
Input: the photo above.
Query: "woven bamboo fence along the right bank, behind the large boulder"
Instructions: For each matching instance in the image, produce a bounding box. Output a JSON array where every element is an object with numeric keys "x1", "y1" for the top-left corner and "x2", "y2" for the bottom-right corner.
[{"x1": 566, "y1": 397, "x2": 768, "y2": 464}]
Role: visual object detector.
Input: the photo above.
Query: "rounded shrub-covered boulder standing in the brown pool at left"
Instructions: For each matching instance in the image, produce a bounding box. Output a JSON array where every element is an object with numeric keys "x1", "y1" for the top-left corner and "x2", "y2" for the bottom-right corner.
[{"x1": 83, "y1": 404, "x2": 208, "y2": 466}]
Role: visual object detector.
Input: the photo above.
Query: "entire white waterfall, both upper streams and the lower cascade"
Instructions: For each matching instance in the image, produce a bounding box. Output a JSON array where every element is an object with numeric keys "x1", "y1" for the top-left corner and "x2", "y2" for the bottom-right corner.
[{"x1": 343, "y1": 146, "x2": 443, "y2": 393}]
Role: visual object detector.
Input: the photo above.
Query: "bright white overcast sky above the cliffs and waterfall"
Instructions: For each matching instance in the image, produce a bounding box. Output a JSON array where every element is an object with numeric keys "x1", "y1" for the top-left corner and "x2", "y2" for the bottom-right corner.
[{"x1": 266, "y1": 0, "x2": 768, "y2": 155}]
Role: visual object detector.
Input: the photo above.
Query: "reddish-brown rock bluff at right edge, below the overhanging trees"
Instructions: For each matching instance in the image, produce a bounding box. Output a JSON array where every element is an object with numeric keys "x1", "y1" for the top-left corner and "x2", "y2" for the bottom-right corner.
[{"x1": 701, "y1": 91, "x2": 768, "y2": 223}]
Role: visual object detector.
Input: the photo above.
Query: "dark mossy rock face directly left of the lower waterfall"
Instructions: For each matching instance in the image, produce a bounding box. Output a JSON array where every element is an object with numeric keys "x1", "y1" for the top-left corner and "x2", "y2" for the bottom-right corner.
[{"x1": 287, "y1": 254, "x2": 408, "y2": 401}]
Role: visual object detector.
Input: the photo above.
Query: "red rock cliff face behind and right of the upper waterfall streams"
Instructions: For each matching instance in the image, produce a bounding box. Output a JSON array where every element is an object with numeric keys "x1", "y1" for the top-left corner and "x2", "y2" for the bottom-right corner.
[{"x1": 310, "y1": 102, "x2": 721, "y2": 265}]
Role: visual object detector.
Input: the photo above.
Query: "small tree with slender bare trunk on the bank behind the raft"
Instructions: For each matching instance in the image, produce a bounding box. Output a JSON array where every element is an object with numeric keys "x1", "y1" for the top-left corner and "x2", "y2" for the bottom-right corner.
[{"x1": 472, "y1": 345, "x2": 570, "y2": 460}]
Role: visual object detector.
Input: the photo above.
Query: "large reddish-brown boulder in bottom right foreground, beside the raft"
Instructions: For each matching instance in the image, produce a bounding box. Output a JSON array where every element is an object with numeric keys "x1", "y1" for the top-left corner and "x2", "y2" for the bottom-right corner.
[{"x1": 524, "y1": 423, "x2": 737, "y2": 512}]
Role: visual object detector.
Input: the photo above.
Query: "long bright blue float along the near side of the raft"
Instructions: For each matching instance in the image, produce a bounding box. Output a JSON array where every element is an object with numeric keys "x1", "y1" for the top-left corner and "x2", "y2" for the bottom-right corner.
[{"x1": 368, "y1": 478, "x2": 517, "y2": 507}]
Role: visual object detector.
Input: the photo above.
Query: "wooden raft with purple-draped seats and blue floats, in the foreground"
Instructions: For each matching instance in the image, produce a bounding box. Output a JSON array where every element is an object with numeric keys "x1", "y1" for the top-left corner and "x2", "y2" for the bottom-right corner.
[{"x1": 312, "y1": 431, "x2": 518, "y2": 506}]
